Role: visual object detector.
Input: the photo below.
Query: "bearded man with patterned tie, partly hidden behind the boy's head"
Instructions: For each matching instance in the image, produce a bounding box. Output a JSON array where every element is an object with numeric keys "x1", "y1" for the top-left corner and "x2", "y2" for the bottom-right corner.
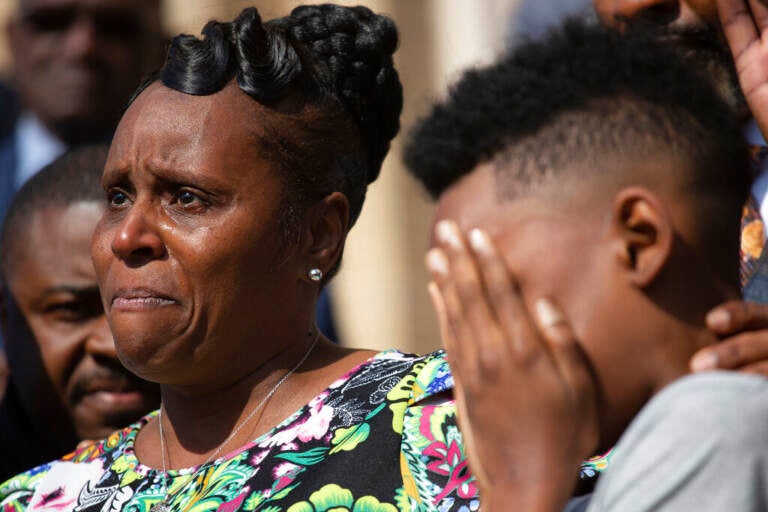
[{"x1": 593, "y1": 0, "x2": 768, "y2": 302}]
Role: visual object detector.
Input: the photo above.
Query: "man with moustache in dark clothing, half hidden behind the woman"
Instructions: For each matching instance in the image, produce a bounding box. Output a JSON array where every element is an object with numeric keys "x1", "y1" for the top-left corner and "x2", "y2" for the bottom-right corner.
[{"x1": 0, "y1": 146, "x2": 160, "y2": 481}]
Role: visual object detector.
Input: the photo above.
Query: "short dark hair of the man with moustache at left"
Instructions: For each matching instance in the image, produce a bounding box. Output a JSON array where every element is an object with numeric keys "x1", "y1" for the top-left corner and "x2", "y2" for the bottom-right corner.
[{"x1": 0, "y1": 144, "x2": 109, "y2": 285}]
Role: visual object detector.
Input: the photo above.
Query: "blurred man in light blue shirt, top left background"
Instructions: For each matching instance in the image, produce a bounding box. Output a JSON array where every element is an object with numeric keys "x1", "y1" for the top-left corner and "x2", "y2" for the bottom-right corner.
[{"x1": 0, "y1": 0, "x2": 165, "y2": 392}]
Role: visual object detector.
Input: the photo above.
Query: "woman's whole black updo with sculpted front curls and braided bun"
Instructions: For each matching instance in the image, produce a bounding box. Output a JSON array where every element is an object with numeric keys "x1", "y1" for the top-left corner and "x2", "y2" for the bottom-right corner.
[{"x1": 134, "y1": 4, "x2": 403, "y2": 233}]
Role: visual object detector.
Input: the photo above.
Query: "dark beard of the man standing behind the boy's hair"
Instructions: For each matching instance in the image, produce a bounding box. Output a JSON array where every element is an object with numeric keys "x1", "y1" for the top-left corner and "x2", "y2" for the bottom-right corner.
[{"x1": 642, "y1": 26, "x2": 750, "y2": 117}]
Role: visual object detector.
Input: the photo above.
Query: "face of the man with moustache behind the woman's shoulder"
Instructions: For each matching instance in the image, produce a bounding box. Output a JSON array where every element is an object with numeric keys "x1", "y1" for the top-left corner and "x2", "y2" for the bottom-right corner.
[{"x1": 4, "y1": 202, "x2": 159, "y2": 440}]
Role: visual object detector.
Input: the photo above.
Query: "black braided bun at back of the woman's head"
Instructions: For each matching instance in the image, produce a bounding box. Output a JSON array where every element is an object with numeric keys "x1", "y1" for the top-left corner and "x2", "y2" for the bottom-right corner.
[{"x1": 284, "y1": 4, "x2": 403, "y2": 183}]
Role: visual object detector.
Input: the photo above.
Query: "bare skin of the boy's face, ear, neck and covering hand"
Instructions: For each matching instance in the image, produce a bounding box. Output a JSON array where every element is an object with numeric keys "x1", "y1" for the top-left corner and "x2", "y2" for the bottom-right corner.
[{"x1": 427, "y1": 158, "x2": 738, "y2": 511}]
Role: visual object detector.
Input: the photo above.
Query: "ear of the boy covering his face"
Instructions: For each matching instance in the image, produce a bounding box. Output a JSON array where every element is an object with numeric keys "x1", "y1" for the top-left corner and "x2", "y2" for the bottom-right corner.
[{"x1": 612, "y1": 187, "x2": 674, "y2": 288}]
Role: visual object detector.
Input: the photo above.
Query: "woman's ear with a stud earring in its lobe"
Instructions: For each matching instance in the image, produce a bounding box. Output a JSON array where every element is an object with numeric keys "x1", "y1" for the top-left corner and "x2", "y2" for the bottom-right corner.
[{"x1": 302, "y1": 192, "x2": 349, "y2": 277}]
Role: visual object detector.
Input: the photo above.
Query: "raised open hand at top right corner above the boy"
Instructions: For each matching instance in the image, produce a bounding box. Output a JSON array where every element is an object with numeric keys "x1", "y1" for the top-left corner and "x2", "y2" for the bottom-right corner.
[{"x1": 717, "y1": 0, "x2": 768, "y2": 137}]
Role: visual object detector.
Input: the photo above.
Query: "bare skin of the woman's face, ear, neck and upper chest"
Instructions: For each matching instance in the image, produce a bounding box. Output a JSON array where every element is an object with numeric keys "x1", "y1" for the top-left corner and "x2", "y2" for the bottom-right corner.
[{"x1": 92, "y1": 83, "x2": 371, "y2": 467}]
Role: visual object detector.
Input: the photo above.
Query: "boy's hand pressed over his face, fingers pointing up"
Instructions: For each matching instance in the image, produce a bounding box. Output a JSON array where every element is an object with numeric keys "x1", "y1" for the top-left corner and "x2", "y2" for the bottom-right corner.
[{"x1": 427, "y1": 221, "x2": 599, "y2": 510}]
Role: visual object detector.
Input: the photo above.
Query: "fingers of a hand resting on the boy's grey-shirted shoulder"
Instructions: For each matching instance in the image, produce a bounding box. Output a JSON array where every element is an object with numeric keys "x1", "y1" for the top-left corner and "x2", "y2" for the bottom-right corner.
[{"x1": 691, "y1": 301, "x2": 768, "y2": 377}]
